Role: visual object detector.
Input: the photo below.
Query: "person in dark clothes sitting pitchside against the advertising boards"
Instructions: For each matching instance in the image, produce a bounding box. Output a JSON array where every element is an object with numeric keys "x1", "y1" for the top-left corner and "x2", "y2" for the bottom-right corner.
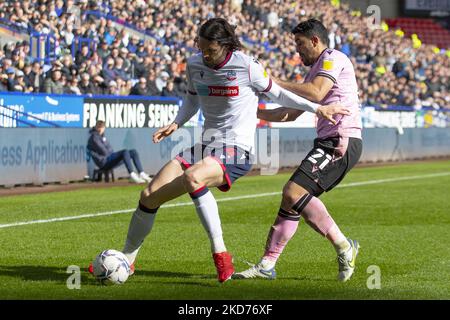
[{"x1": 87, "y1": 121, "x2": 151, "y2": 183}]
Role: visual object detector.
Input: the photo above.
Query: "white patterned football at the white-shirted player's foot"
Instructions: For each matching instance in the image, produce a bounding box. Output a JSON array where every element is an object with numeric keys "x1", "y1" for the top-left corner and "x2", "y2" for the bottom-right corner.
[{"x1": 92, "y1": 249, "x2": 130, "y2": 284}]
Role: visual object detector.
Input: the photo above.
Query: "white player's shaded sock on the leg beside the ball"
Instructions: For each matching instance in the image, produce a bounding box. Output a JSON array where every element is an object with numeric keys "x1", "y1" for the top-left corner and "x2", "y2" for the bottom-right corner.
[{"x1": 122, "y1": 207, "x2": 156, "y2": 263}]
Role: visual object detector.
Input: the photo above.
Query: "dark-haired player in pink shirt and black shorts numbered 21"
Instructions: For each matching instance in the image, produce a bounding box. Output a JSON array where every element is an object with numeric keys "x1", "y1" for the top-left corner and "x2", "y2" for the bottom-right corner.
[{"x1": 234, "y1": 19, "x2": 362, "y2": 281}]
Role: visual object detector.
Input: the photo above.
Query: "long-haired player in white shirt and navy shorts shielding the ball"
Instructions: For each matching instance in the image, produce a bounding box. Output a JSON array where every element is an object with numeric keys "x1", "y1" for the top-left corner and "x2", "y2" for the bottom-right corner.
[{"x1": 94, "y1": 18, "x2": 349, "y2": 282}]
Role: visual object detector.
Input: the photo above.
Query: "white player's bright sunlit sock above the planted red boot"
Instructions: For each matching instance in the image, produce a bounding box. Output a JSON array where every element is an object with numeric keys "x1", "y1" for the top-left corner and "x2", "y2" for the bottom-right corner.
[{"x1": 191, "y1": 191, "x2": 227, "y2": 253}]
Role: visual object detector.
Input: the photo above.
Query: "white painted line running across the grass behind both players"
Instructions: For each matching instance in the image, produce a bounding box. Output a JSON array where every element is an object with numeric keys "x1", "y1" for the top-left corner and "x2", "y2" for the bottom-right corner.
[{"x1": 0, "y1": 172, "x2": 450, "y2": 229}]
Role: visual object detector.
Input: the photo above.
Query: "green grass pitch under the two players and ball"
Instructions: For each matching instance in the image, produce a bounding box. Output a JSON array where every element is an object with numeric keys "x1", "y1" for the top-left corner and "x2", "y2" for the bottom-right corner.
[{"x1": 0, "y1": 161, "x2": 450, "y2": 300}]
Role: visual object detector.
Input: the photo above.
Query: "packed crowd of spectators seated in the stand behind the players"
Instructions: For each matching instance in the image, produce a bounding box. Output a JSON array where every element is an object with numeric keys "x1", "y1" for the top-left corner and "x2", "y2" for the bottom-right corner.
[{"x1": 0, "y1": 0, "x2": 450, "y2": 109}]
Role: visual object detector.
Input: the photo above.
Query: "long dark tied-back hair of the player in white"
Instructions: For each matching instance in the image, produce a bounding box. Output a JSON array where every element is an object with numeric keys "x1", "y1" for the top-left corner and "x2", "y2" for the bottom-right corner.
[{"x1": 199, "y1": 18, "x2": 242, "y2": 51}]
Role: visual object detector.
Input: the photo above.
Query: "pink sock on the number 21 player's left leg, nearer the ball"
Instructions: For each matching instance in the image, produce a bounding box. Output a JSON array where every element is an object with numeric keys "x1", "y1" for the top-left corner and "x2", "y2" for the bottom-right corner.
[{"x1": 263, "y1": 209, "x2": 300, "y2": 262}]
